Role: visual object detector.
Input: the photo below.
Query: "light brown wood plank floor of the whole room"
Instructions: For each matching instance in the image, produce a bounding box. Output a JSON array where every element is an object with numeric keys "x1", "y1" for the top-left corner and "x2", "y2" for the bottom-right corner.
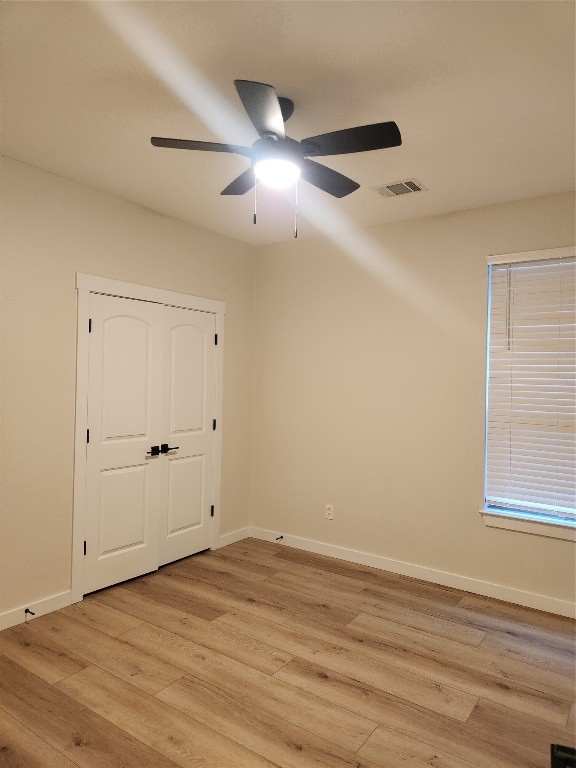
[{"x1": 0, "y1": 539, "x2": 576, "y2": 768}]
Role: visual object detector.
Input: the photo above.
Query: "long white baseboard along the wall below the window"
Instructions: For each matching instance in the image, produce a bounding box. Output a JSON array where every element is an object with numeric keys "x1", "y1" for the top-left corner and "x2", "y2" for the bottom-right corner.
[{"x1": 248, "y1": 527, "x2": 576, "y2": 618}]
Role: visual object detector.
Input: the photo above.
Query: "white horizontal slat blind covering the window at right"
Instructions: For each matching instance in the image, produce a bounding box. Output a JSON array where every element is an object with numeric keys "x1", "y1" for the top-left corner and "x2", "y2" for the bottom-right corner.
[{"x1": 485, "y1": 248, "x2": 576, "y2": 521}]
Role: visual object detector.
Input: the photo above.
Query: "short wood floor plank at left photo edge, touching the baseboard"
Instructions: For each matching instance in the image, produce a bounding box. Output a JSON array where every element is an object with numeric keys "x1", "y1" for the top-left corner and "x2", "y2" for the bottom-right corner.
[{"x1": 0, "y1": 619, "x2": 88, "y2": 683}]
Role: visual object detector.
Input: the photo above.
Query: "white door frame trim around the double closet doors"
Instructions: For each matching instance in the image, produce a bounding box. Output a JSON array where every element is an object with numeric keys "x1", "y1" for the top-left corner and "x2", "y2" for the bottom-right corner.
[{"x1": 70, "y1": 272, "x2": 225, "y2": 603}]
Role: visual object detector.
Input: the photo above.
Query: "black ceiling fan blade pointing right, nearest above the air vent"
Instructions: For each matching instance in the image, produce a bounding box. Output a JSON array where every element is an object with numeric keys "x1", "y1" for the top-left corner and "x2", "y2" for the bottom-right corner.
[{"x1": 301, "y1": 121, "x2": 402, "y2": 157}]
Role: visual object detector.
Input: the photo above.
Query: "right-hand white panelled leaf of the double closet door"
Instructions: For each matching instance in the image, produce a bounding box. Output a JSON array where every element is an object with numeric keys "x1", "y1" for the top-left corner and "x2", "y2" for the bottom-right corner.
[{"x1": 159, "y1": 307, "x2": 216, "y2": 565}]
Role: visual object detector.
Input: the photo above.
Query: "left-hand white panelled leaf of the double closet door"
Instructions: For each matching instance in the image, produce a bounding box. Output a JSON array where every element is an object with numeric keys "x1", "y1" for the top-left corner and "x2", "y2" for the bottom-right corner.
[{"x1": 84, "y1": 295, "x2": 166, "y2": 593}]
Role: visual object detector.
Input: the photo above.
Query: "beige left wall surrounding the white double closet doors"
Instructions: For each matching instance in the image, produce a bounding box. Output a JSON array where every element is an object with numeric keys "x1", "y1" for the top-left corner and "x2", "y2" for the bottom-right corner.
[{"x1": 0, "y1": 160, "x2": 253, "y2": 613}]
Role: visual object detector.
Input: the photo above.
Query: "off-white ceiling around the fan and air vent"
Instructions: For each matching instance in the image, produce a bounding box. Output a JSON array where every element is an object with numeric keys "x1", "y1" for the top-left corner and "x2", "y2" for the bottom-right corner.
[{"x1": 0, "y1": 0, "x2": 575, "y2": 244}]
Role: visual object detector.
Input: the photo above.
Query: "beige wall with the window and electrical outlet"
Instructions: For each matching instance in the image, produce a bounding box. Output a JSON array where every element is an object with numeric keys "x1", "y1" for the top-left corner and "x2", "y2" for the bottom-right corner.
[{"x1": 251, "y1": 195, "x2": 575, "y2": 600}]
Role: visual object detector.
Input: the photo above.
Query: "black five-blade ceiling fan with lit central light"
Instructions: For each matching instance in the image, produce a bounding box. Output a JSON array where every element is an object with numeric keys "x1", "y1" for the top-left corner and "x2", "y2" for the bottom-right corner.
[{"x1": 150, "y1": 80, "x2": 402, "y2": 197}]
